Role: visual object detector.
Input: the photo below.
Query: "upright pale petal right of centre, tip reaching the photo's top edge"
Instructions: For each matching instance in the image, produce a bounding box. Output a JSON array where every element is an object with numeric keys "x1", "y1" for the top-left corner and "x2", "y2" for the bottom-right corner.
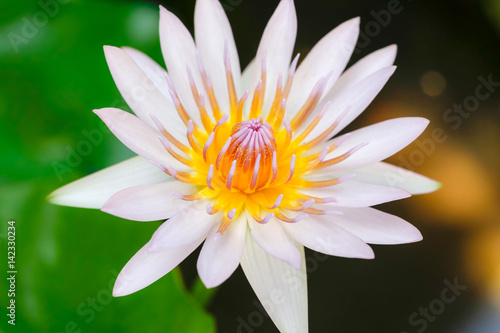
[{"x1": 246, "y1": 0, "x2": 297, "y2": 115}]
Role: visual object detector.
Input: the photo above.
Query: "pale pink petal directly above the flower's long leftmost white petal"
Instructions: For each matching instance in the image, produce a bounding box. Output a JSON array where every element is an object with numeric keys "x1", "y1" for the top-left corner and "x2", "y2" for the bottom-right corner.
[{"x1": 94, "y1": 108, "x2": 190, "y2": 171}]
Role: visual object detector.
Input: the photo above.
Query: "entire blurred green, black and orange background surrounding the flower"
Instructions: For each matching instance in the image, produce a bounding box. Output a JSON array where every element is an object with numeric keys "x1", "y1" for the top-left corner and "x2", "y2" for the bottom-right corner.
[{"x1": 0, "y1": 0, "x2": 500, "y2": 333}]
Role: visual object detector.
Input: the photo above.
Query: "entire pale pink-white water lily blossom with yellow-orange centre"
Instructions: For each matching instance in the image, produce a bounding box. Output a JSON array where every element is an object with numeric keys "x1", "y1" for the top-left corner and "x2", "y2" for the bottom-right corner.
[{"x1": 50, "y1": 0, "x2": 438, "y2": 333}]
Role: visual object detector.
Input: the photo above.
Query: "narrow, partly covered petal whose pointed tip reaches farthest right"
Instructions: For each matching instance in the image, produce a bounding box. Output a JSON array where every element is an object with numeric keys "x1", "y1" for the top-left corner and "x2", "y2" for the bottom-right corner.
[{"x1": 311, "y1": 162, "x2": 441, "y2": 195}]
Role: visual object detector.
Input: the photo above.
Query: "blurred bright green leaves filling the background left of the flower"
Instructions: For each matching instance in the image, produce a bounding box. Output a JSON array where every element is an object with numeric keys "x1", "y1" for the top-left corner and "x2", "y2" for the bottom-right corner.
[{"x1": 0, "y1": 0, "x2": 215, "y2": 333}]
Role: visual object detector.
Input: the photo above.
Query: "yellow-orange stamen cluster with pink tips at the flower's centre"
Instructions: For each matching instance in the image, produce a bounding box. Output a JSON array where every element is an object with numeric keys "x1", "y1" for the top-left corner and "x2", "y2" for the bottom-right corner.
[{"x1": 148, "y1": 40, "x2": 366, "y2": 234}]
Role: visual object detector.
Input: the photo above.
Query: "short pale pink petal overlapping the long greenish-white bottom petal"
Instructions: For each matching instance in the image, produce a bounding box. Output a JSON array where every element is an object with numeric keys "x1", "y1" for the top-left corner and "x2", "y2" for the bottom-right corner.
[{"x1": 248, "y1": 213, "x2": 302, "y2": 269}]
